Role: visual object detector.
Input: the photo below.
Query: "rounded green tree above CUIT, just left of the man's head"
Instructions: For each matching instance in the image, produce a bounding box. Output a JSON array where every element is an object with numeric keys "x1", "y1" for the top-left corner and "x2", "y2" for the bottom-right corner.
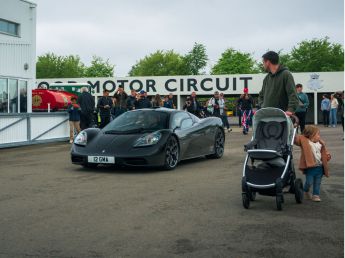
[{"x1": 211, "y1": 48, "x2": 259, "y2": 75}]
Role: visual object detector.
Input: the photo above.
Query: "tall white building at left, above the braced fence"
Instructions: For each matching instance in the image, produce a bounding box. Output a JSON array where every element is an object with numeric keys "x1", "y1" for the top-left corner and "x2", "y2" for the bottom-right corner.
[{"x1": 0, "y1": 0, "x2": 36, "y2": 114}]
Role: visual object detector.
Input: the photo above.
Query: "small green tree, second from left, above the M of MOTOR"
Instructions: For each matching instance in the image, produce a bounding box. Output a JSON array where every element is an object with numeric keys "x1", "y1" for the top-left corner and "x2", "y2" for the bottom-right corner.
[{"x1": 84, "y1": 56, "x2": 115, "y2": 77}]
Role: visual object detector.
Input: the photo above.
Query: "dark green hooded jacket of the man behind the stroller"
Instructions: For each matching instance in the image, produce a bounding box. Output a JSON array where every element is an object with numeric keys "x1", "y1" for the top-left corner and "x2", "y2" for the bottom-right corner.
[{"x1": 259, "y1": 66, "x2": 298, "y2": 112}]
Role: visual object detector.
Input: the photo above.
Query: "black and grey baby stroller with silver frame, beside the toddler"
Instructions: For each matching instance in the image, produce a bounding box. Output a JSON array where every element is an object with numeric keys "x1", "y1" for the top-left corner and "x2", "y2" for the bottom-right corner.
[{"x1": 242, "y1": 108, "x2": 303, "y2": 210}]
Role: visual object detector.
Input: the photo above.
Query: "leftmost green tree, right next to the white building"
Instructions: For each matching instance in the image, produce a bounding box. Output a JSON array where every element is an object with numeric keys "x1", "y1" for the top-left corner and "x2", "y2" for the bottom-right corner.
[{"x1": 36, "y1": 53, "x2": 85, "y2": 78}]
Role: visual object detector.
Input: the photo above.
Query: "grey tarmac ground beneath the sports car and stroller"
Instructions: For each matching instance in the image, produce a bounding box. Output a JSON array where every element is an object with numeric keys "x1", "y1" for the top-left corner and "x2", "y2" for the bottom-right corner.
[{"x1": 0, "y1": 127, "x2": 344, "y2": 258}]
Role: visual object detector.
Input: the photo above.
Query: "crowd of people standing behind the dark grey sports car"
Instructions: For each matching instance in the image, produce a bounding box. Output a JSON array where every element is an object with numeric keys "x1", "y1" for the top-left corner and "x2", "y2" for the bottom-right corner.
[{"x1": 68, "y1": 87, "x2": 247, "y2": 139}]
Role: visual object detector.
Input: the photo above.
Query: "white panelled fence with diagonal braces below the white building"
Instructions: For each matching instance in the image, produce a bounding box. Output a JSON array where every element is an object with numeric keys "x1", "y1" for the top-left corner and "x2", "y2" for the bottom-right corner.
[{"x1": 0, "y1": 112, "x2": 69, "y2": 148}]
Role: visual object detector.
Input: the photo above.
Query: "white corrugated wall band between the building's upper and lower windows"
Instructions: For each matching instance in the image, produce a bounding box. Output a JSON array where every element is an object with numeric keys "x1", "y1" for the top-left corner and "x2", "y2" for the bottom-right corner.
[{"x1": 0, "y1": 42, "x2": 32, "y2": 78}]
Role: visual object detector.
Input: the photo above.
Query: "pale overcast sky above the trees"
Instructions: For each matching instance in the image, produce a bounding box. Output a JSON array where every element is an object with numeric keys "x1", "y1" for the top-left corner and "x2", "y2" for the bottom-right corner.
[{"x1": 32, "y1": 0, "x2": 344, "y2": 77}]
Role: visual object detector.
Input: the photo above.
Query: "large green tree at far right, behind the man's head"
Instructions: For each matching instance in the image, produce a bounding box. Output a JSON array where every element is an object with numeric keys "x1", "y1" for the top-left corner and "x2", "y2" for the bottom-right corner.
[{"x1": 285, "y1": 37, "x2": 344, "y2": 72}]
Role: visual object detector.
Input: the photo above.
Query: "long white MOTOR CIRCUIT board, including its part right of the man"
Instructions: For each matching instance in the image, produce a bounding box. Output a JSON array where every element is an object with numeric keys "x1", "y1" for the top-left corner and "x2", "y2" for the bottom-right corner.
[{"x1": 36, "y1": 72, "x2": 344, "y2": 96}]
